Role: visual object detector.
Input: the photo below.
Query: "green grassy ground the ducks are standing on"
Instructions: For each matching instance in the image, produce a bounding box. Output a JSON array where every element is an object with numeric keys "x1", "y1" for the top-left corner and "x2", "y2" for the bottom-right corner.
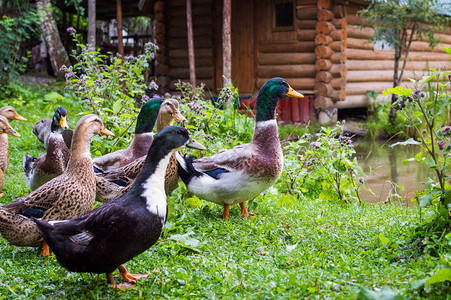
[{"x1": 0, "y1": 100, "x2": 443, "y2": 299}]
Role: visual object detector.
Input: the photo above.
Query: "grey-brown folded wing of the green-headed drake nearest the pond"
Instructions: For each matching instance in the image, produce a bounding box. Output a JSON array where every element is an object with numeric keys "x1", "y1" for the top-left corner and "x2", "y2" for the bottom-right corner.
[{"x1": 193, "y1": 144, "x2": 252, "y2": 173}]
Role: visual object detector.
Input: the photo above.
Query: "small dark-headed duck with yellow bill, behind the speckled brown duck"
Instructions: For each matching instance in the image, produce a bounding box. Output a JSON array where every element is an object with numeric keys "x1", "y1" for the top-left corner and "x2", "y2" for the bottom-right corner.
[{"x1": 23, "y1": 107, "x2": 69, "y2": 190}]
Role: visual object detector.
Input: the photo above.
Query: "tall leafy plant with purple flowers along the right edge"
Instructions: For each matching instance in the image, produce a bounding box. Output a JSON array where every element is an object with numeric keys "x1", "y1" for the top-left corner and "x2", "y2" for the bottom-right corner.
[{"x1": 384, "y1": 52, "x2": 451, "y2": 290}]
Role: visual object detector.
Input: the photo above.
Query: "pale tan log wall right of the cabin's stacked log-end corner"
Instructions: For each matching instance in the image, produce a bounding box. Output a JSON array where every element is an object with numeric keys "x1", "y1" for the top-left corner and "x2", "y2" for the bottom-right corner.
[{"x1": 342, "y1": 0, "x2": 451, "y2": 108}]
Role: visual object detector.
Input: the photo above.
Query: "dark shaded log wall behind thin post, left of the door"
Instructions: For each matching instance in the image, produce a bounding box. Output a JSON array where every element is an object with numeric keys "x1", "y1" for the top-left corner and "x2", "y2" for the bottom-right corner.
[{"x1": 166, "y1": 0, "x2": 215, "y2": 91}]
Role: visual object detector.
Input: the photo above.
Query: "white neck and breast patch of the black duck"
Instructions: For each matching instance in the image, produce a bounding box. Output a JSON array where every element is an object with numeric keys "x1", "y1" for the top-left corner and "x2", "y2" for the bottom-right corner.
[{"x1": 142, "y1": 152, "x2": 172, "y2": 226}]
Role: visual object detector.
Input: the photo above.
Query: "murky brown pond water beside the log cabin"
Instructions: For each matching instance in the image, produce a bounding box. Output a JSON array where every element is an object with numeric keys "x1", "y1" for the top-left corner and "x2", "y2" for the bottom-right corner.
[{"x1": 354, "y1": 141, "x2": 433, "y2": 206}]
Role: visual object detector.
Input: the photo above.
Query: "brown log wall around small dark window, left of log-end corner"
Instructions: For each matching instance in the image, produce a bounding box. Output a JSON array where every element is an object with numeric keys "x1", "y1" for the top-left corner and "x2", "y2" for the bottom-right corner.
[{"x1": 256, "y1": 0, "x2": 318, "y2": 94}]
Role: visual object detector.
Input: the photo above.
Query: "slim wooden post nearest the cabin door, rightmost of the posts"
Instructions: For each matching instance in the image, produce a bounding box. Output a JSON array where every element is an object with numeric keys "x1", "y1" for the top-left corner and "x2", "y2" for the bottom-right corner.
[{"x1": 222, "y1": 0, "x2": 232, "y2": 80}]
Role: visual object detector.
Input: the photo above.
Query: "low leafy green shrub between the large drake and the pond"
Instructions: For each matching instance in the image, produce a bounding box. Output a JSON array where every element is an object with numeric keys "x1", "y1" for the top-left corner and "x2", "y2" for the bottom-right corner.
[{"x1": 278, "y1": 122, "x2": 364, "y2": 202}]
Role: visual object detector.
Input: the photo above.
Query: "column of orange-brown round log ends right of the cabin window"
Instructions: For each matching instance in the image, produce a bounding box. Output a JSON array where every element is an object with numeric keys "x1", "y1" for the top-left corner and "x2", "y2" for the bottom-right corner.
[{"x1": 315, "y1": 0, "x2": 346, "y2": 109}]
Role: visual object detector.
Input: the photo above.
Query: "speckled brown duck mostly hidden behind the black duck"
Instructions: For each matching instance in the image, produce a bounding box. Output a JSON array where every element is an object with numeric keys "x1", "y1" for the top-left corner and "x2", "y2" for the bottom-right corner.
[{"x1": 96, "y1": 98, "x2": 186, "y2": 203}]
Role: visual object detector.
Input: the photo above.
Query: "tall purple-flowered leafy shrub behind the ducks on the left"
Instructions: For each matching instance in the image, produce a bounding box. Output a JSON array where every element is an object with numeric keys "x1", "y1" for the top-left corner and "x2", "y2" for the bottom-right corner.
[{"x1": 62, "y1": 28, "x2": 158, "y2": 154}]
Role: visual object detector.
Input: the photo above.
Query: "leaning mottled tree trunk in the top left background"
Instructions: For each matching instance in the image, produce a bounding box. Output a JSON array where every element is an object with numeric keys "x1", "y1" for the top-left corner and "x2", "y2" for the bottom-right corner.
[{"x1": 38, "y1": 0, "x2": 70, "y2": 78}]
